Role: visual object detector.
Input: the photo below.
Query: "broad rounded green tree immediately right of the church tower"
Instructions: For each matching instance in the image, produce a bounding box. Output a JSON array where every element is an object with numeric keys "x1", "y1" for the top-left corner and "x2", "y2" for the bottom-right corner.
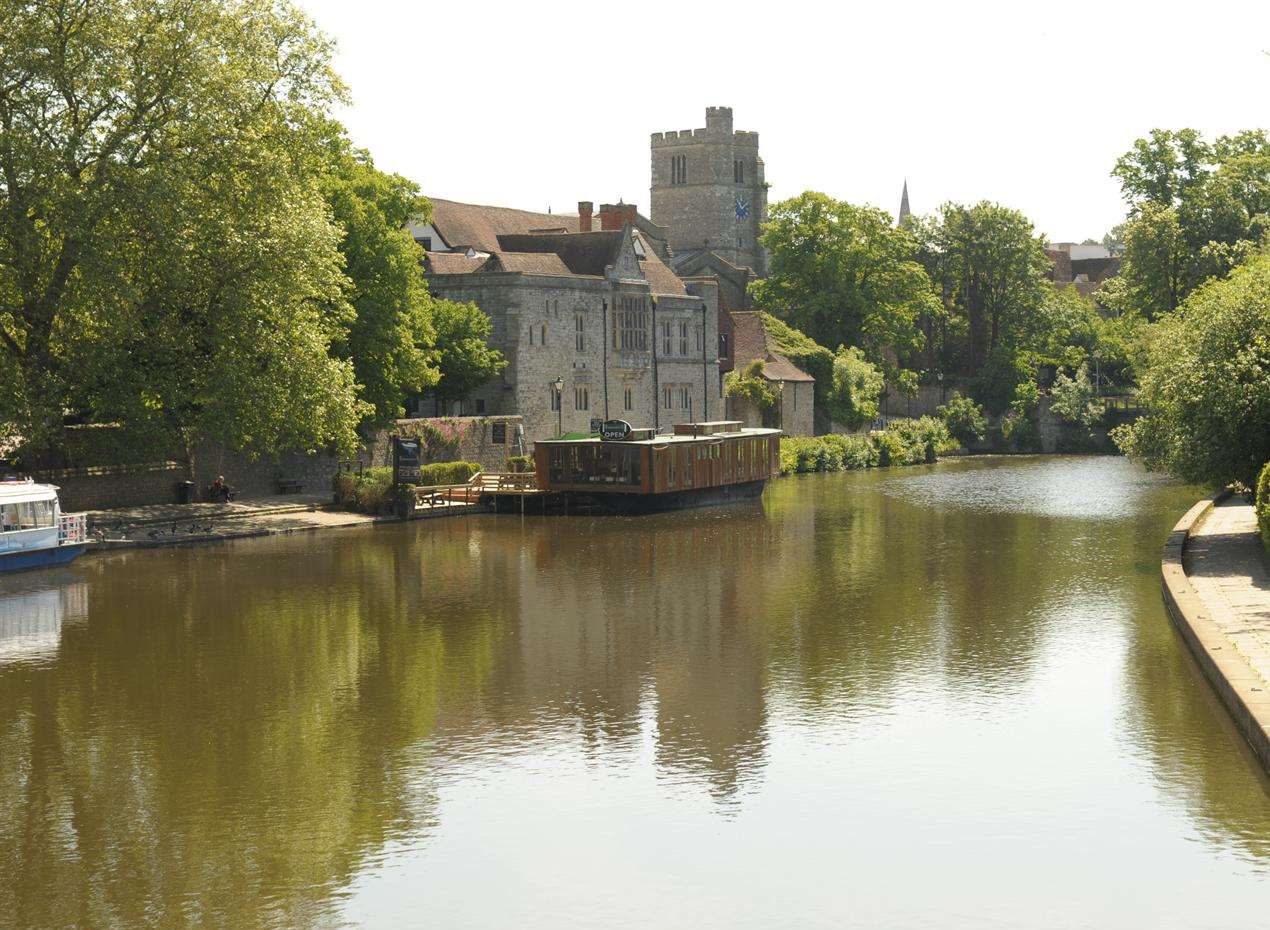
[{"x1": 751, "y1": 191, "x2": 939, "y2": 361}]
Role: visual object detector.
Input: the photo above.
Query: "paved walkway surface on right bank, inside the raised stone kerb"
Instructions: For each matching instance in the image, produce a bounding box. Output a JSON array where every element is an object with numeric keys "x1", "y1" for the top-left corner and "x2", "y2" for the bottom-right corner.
[{"x1": 1182, "y1": 497, "x2": 1270, "y2": 691}]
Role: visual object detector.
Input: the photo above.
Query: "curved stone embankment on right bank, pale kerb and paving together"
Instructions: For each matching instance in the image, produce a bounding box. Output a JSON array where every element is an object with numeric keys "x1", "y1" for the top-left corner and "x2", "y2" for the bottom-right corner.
[{"x1": 1161, "y1": 495, "x2": 1270, "y2": 770}]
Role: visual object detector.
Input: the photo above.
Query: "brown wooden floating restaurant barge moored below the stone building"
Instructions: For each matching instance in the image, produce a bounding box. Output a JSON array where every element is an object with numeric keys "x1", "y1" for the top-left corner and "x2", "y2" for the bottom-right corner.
[{"x1": 533, "y1": 421, "x2": 781, "y2": 513}]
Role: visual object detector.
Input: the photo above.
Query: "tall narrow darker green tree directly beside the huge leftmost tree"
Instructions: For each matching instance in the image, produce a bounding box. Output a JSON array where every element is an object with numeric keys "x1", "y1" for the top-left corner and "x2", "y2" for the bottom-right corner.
[{"x1": 323, "y1": 137, "x2": 439, "y2": 424}]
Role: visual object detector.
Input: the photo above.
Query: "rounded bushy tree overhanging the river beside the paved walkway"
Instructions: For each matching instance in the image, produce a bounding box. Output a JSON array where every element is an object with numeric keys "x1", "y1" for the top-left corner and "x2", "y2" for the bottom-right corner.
[{"x1": 1113, "y1": 255, "x2": 1270, "y2": 488}]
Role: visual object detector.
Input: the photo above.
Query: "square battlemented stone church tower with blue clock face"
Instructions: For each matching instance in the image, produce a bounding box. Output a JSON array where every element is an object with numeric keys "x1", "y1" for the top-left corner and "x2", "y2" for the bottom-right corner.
[{"x1": 650, "y1": 107, "x2": 767, "y2": 274}]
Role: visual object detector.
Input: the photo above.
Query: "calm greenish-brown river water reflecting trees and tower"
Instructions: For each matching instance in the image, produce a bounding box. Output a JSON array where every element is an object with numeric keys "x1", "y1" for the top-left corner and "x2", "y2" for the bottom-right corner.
[{"x1": 0, "y1": 457, "x2": 1270, "y2": 930}]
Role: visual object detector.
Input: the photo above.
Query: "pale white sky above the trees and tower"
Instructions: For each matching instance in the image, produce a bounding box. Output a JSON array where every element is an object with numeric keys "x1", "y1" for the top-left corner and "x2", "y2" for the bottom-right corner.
[{"x1": 297, "y1": 0, "x2": 1270, "y2": 241}]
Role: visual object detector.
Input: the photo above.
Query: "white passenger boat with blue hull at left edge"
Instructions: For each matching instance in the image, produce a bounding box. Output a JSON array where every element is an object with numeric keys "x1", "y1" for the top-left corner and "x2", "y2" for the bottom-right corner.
[{"x1": 0, "y1": 478, "x2": 89, "y2": 572}]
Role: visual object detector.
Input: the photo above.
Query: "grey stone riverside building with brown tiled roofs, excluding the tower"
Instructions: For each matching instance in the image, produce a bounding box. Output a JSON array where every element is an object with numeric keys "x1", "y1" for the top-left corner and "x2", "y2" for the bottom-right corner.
[{"x1": 413, "y1": 201, "x2": 723, "y2": 442}]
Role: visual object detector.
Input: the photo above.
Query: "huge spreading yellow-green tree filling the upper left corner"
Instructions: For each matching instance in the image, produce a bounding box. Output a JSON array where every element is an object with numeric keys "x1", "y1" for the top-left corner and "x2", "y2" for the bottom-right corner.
[{"x1": 0, "y1": 0, "x2": 364, "y2": 462}]
